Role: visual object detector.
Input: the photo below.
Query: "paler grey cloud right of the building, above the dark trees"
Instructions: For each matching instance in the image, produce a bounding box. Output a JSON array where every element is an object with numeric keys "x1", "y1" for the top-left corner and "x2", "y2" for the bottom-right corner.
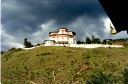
[{"x1": 69, "y1": 16, "x2": 107, "y2": 41}]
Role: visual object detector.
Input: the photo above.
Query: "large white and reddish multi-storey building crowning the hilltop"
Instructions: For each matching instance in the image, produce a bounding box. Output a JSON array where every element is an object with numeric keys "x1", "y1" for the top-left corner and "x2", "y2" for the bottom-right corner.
[{"x1": 49, "y1": 28, "x2": 76, "y2": 44}]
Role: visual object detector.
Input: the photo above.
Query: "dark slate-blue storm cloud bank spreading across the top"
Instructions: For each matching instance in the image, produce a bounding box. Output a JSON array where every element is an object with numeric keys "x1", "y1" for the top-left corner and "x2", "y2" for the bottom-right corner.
[{"x1": 2, "y1": 0, "x2": 104, "y2": 32}]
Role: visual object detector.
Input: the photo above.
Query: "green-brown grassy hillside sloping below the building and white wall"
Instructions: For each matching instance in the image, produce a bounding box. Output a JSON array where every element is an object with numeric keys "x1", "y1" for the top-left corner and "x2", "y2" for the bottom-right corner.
[{"x1": 1, "y1": 46, "x2": 128, "y2": 84}]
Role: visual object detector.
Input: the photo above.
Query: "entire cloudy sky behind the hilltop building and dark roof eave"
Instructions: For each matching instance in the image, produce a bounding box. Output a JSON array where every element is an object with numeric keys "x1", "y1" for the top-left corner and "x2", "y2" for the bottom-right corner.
[{"x1": 1, "y1": 0, "x2": 128, "y2": 50}]
